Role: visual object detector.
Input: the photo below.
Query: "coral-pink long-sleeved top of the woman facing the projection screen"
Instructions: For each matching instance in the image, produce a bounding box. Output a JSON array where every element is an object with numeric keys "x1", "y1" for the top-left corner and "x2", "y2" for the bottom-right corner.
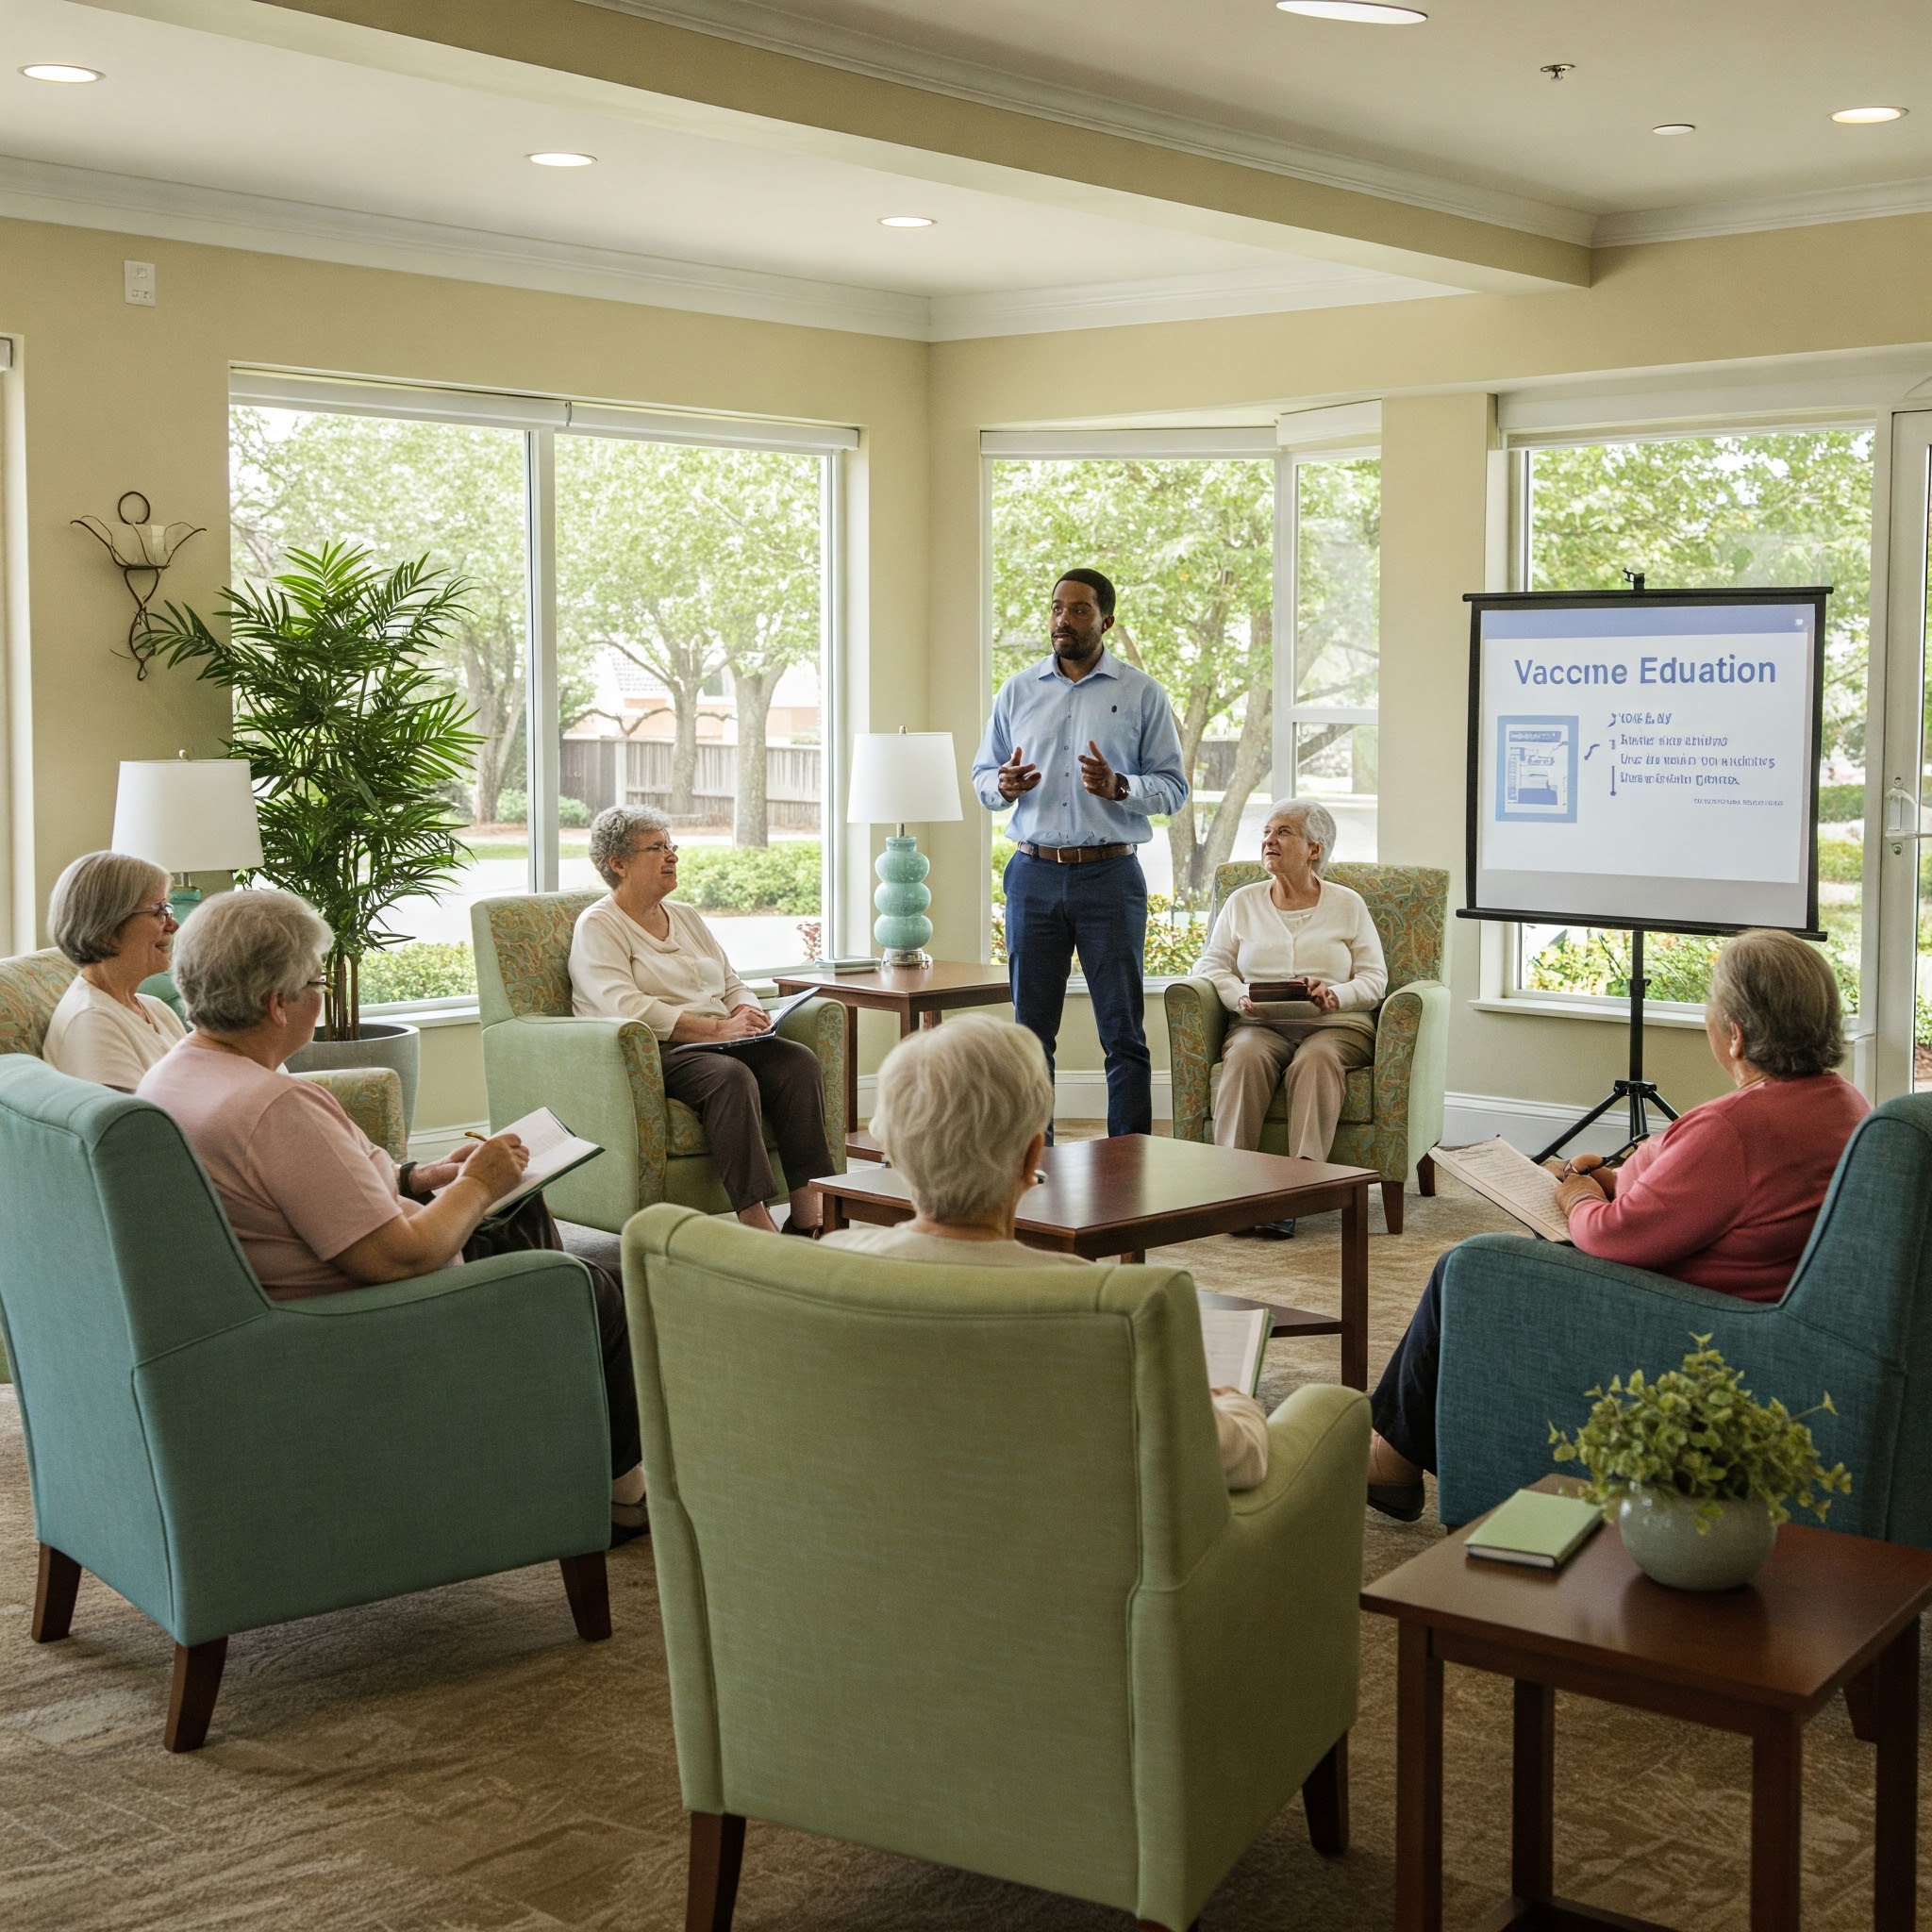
[{"x1": 1568, "y1": 1074, "x2": 1870, "y2": 1302}]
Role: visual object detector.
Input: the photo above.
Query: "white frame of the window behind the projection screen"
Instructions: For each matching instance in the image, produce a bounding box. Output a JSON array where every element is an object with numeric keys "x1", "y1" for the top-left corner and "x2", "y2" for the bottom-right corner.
[{"x1": 1499, "y1": 411, "x2": 1890, "y2": 1036}]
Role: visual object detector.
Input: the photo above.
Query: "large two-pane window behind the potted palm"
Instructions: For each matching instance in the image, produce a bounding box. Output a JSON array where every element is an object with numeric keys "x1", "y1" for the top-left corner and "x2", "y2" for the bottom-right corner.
[{"x1": 232, "y1": 378, "x2": 837, "y2": 1005}]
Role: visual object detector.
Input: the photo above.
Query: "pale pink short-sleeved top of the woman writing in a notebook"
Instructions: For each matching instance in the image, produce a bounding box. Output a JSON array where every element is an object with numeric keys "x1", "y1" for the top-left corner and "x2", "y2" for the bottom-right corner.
[{"x1": 135, "y1": 1036, "x2": 421, "y2": 1300}]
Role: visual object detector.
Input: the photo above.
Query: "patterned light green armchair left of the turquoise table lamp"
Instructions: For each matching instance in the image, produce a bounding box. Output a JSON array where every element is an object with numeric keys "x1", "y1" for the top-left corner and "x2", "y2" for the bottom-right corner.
[{"x1": 470, "y1": 892, "x2": 846, "y2": 1235}]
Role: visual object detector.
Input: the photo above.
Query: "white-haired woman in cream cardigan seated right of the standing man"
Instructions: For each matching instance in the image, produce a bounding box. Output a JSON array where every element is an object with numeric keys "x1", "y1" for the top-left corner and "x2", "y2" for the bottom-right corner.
[{"x1": 1196, "y1": 798, "x2": 1390, "y2": 1237}]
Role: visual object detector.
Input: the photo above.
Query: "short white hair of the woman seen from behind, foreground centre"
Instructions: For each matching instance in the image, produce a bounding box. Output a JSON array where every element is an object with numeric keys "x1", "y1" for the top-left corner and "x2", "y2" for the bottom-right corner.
[{"x1": 872, "y1": 1014, "x2": 1053, "y2": 1223}]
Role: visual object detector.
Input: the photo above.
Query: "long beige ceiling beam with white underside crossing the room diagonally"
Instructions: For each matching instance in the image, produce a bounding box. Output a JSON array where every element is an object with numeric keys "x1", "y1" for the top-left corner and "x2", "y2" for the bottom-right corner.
[{"x1": 83, "y1": 0, "x2": 1591, "y2": 293}]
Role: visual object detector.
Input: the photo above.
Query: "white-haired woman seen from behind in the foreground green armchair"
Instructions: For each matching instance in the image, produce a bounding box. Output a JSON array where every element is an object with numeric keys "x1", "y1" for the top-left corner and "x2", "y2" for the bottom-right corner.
[{"x1": 824, "y1": 1014, "x2": 1267, "y2": 1490}]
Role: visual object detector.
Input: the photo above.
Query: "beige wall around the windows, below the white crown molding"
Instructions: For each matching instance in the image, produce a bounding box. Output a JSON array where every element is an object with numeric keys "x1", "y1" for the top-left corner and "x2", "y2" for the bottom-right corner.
[{"x1": 0, "y1": 216, "x2": 1932, "y2": 1124}]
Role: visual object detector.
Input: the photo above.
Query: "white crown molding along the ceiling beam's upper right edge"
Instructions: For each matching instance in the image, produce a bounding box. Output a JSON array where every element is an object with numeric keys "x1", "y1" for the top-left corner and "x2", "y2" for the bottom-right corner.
[{"x1": 590, "y1": 0, "x2": 1594, "y2": 243}]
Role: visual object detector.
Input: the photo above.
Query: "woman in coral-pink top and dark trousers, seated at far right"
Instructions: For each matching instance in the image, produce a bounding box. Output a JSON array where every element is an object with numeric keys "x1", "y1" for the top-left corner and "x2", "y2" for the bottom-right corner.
[{"x1": 1368, "y1": 931, "x2": 1868, "y2": 1523}]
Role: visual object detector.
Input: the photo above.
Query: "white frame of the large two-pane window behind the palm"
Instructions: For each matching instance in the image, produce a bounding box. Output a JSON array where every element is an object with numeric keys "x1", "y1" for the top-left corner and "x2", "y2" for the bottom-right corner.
[{"x1": 228, "y1": 363, "x2": 859, "y2": 1025}]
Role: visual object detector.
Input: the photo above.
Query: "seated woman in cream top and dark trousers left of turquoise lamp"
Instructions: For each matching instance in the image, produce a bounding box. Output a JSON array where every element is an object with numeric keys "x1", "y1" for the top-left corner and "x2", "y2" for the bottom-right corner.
[{"x1": 570, "y1": 806, "x2": 833, "y2": 1235}]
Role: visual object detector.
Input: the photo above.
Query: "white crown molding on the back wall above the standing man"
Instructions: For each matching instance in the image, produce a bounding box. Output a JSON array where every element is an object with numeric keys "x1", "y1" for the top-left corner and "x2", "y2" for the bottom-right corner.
[{"x1": 929, "y1": 263, "x2": 1466, "y2": 341}]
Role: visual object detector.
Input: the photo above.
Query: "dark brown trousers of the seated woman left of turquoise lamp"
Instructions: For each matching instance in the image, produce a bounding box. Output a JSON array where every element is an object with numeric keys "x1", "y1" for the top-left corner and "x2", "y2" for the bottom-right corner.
[{"x1": 660, "y1": 1038, "x2": 833, "y2": 1211}]
